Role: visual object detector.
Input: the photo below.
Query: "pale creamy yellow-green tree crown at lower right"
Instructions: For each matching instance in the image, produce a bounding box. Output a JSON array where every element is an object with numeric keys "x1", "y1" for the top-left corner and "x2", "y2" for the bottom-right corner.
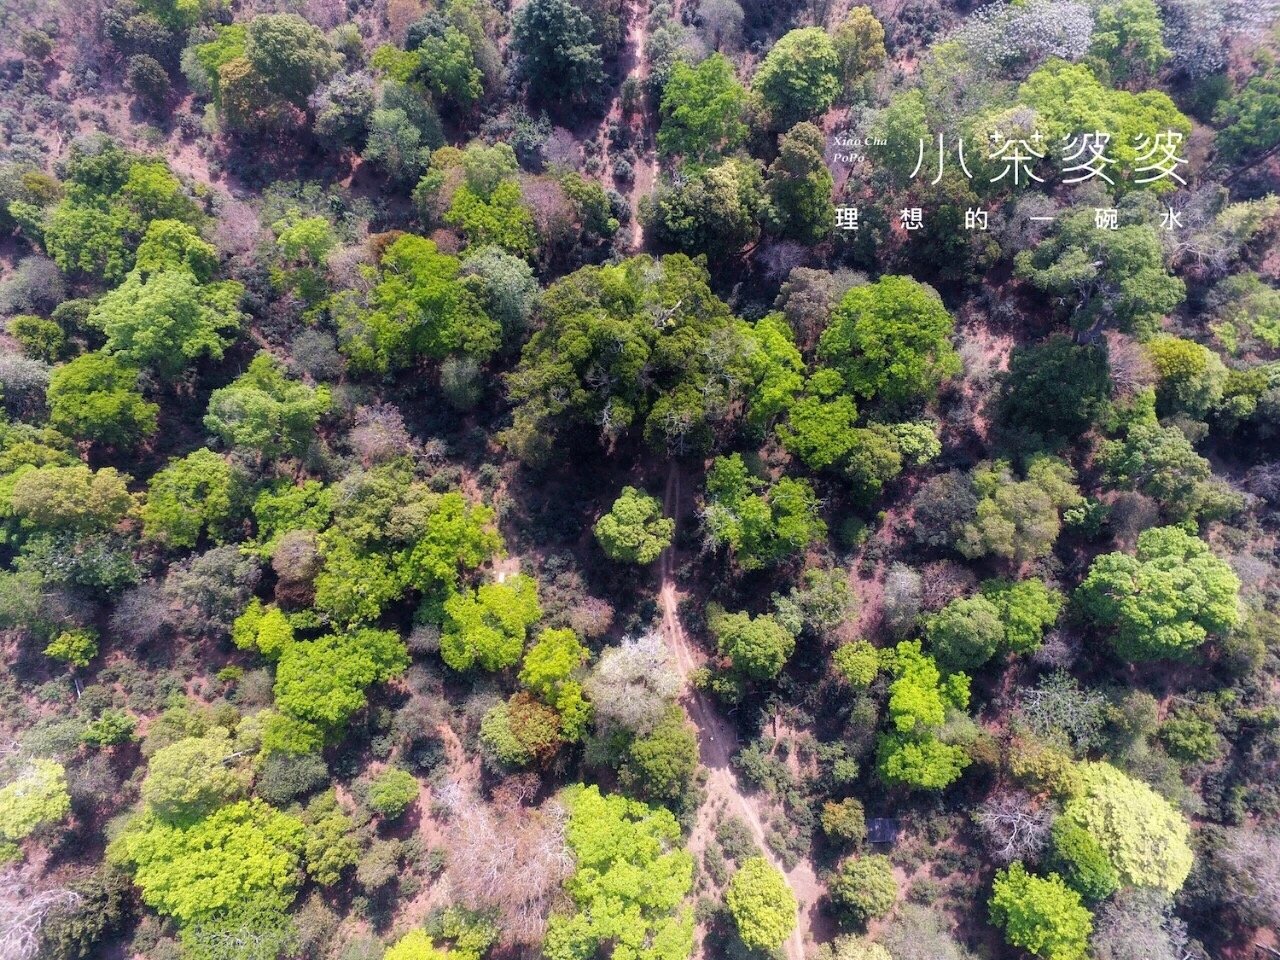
[{"x1": 1061, "y1": 763, "x2": 1194, "y2": 895}]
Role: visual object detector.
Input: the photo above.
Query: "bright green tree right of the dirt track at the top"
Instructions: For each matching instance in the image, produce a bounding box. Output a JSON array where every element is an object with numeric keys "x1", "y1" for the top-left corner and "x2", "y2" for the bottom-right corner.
[{"x1": 658, "y1": 54, "x2": 746, "y2": 161}]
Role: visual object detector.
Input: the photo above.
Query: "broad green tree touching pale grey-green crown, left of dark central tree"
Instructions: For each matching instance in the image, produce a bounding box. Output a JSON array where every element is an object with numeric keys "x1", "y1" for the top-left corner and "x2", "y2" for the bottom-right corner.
[{"x1": 338, "y1": 236, "x2": 502, "y2": 372}]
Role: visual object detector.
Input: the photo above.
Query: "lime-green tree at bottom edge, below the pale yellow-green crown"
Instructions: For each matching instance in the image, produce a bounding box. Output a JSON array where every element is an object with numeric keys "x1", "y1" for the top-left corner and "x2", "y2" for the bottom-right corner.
[{"x1": 989, "y1": 863, "x2": 1093, "y2": 960}]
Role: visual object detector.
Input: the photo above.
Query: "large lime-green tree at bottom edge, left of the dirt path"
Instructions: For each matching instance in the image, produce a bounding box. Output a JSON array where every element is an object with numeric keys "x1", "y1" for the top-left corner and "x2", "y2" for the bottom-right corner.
[{"x1": 543, "y1": 786, "x2": 694, "y2": 960}]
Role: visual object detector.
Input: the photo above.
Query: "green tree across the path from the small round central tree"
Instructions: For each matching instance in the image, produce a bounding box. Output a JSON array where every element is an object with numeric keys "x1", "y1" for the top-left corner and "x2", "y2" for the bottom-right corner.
[{"x1": 703, "y1": 453, "x2": 827, "y2": 570}]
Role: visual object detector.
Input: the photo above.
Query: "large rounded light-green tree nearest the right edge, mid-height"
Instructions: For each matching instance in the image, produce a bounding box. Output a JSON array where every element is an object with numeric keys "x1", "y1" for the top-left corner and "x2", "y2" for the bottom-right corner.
[{"x1": 1075, "y1": 526, "x2": 1240, "y2": 660}]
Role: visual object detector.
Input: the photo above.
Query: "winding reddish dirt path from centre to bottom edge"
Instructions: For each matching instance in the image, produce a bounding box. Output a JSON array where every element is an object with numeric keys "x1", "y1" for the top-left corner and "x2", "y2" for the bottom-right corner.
[{"x1": 658, "y1": 463, "x2": 822, "y2": 960}]
